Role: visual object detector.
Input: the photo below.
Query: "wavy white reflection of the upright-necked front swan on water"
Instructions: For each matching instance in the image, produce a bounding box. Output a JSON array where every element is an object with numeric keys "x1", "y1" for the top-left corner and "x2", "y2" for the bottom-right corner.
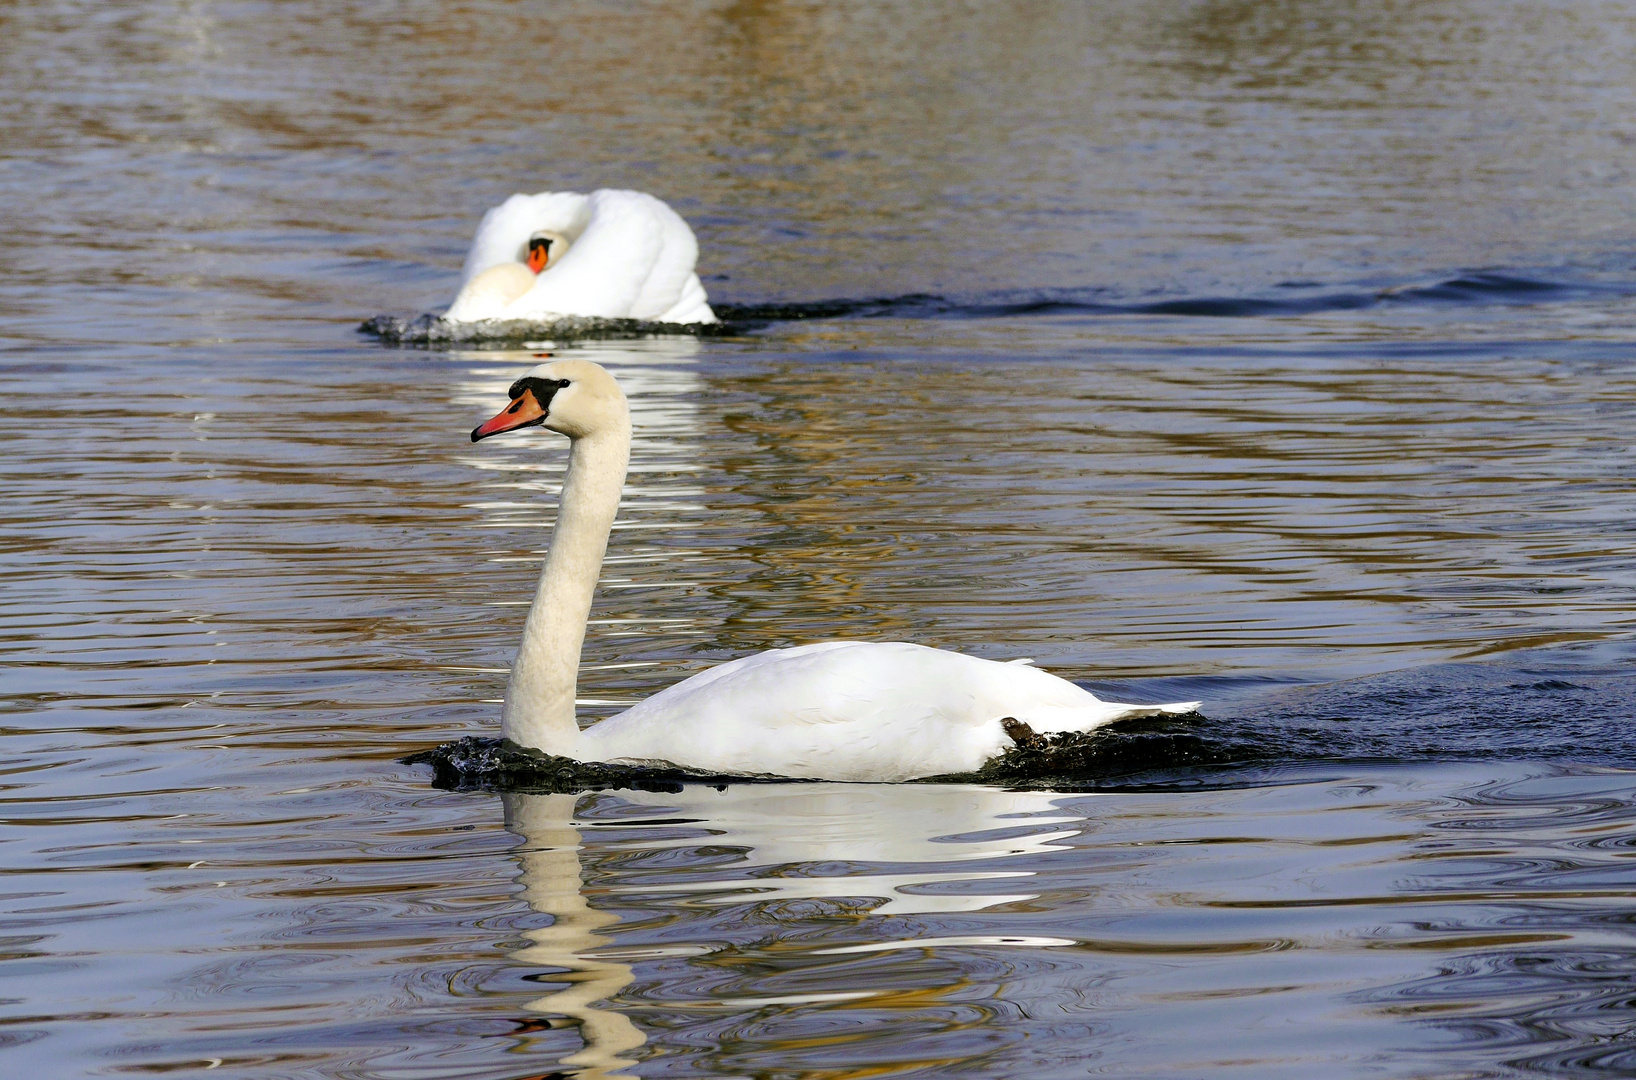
[{"x1": 504, "y1": 784, "x2": 1085, "y2": 1077}]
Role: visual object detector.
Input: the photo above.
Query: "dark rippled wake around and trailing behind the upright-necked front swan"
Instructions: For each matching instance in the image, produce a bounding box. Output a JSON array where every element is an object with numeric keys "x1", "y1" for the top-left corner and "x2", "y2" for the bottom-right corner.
[{"x1": 404, "y1": 640, "x2": 1636, "y2": 792}]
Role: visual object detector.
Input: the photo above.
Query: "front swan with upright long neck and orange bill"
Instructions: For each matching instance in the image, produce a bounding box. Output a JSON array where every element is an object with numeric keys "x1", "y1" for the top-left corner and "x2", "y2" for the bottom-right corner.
[{"x1": 471, "y1": 358, "x2": 1199, "y2": 782}]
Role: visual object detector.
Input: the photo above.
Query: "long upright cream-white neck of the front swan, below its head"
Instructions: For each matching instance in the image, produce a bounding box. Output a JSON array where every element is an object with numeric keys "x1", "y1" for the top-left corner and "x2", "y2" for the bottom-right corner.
[{"x1": 501, "y1": 416, "x2": 630, "y2": 758}]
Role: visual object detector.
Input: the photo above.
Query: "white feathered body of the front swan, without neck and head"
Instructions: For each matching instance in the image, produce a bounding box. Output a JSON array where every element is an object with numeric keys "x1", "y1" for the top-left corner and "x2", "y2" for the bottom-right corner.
[{"x1": 579, "y1": 641, "x2": 1191, "y2": 781}]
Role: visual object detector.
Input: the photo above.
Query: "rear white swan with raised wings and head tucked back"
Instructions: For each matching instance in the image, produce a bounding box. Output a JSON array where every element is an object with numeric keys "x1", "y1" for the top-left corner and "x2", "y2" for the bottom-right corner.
[{"x1": 443, "y1": 190, "x2": 717, "y2": 322}]
